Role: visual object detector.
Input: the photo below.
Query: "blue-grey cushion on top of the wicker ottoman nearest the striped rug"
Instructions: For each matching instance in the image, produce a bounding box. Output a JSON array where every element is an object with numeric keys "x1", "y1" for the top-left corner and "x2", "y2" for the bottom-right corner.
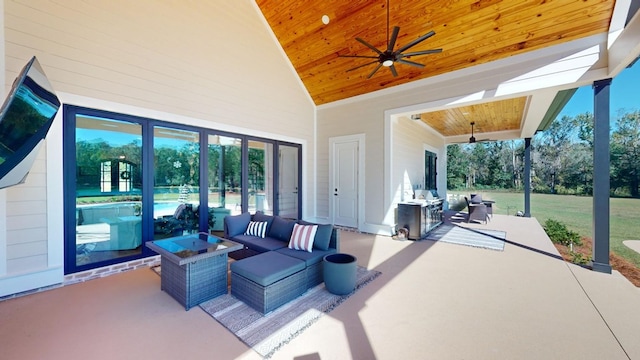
[{"x1": 231, "y1": 251, "x2": 305, "y2": 286}]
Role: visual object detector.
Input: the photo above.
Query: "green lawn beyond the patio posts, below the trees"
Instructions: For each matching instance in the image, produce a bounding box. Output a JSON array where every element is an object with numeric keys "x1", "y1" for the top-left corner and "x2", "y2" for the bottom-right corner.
[{"x1": 450, "y1": 191, "x2": 640, "y2": 267}]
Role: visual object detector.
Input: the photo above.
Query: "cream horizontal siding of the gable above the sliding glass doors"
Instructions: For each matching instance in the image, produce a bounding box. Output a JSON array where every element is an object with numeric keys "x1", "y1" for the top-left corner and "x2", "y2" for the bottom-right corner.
[{"x1": 6, "y1": 0, "x2": 313, "y2": 138}]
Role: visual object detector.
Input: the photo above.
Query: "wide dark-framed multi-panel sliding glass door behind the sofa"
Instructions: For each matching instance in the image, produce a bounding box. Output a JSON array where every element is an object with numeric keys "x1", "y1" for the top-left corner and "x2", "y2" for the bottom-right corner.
[{"x1": 63, "y1": 105, "x2": 302, "y2": 274}]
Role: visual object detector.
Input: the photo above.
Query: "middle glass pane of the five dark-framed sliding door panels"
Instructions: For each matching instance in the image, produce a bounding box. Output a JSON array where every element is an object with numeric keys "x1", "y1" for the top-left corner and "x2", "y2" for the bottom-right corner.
[{"x1": 207, "y1": 135, "x2": 242, "y2": 231}]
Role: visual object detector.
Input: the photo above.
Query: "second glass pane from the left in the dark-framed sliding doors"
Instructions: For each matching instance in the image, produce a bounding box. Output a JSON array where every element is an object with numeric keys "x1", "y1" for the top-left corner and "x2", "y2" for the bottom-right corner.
[{"x1": 153, "y1": 126, "x2": 200, "y2": 239}]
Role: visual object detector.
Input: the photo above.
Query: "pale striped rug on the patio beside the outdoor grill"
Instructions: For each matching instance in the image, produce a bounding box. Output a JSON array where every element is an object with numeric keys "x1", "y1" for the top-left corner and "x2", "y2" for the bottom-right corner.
[{"x1": 426, "y1": 224, "x2": 507, "y2": 251}]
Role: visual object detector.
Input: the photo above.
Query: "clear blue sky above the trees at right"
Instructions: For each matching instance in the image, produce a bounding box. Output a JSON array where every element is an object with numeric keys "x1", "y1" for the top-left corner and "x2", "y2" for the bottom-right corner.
[{"x1": 557, "y1": 61, "x2": 640, "y2": 117}]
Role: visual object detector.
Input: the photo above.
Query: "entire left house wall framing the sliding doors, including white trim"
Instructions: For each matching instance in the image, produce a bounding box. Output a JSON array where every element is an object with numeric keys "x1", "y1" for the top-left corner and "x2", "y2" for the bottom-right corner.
[{"x1": 0, "y1": 0, "x2": 315, "y2": 296}]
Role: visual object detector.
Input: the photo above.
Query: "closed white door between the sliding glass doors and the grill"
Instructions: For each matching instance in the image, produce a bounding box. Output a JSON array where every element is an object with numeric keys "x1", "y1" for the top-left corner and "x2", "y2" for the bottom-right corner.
[{"x1": 330, "y1": 138, "x2": 359, "y2": 228}]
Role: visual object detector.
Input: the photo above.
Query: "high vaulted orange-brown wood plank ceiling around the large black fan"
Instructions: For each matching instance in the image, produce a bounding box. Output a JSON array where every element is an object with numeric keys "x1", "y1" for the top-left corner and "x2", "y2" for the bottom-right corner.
[{"x1": 256, "y1": 0, "x2": 615, "y2": 134}]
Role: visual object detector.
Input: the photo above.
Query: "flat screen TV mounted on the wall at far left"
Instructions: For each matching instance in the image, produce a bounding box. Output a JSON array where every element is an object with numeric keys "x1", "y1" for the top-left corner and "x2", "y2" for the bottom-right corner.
[{"x1": 0, "y1": 56, "x2": 60, "y2": 189}]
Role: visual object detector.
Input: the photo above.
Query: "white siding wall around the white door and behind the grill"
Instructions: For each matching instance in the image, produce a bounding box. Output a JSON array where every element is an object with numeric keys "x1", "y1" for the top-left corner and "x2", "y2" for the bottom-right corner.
[{"x1": 316, "y1": 95, "x2": 446, "y2": 235}]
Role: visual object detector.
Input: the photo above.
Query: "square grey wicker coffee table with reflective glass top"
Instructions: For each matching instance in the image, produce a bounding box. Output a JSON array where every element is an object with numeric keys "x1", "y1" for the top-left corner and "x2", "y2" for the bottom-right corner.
[{"x1": 146, "y1": 233, "x2": 242, "y2": 310}]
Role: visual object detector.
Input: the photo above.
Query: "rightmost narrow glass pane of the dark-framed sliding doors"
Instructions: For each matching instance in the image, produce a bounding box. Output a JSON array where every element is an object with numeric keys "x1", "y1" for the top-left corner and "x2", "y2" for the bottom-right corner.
[{"x1": 278, "y1": 145, "x2": 299, "y2": 219}]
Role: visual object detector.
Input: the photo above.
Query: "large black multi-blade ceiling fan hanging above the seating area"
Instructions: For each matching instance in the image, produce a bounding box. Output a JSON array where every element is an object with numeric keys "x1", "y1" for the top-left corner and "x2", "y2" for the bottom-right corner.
[{"x1": 338, "y1": 0, "x2": 442, "y2": 79}]
